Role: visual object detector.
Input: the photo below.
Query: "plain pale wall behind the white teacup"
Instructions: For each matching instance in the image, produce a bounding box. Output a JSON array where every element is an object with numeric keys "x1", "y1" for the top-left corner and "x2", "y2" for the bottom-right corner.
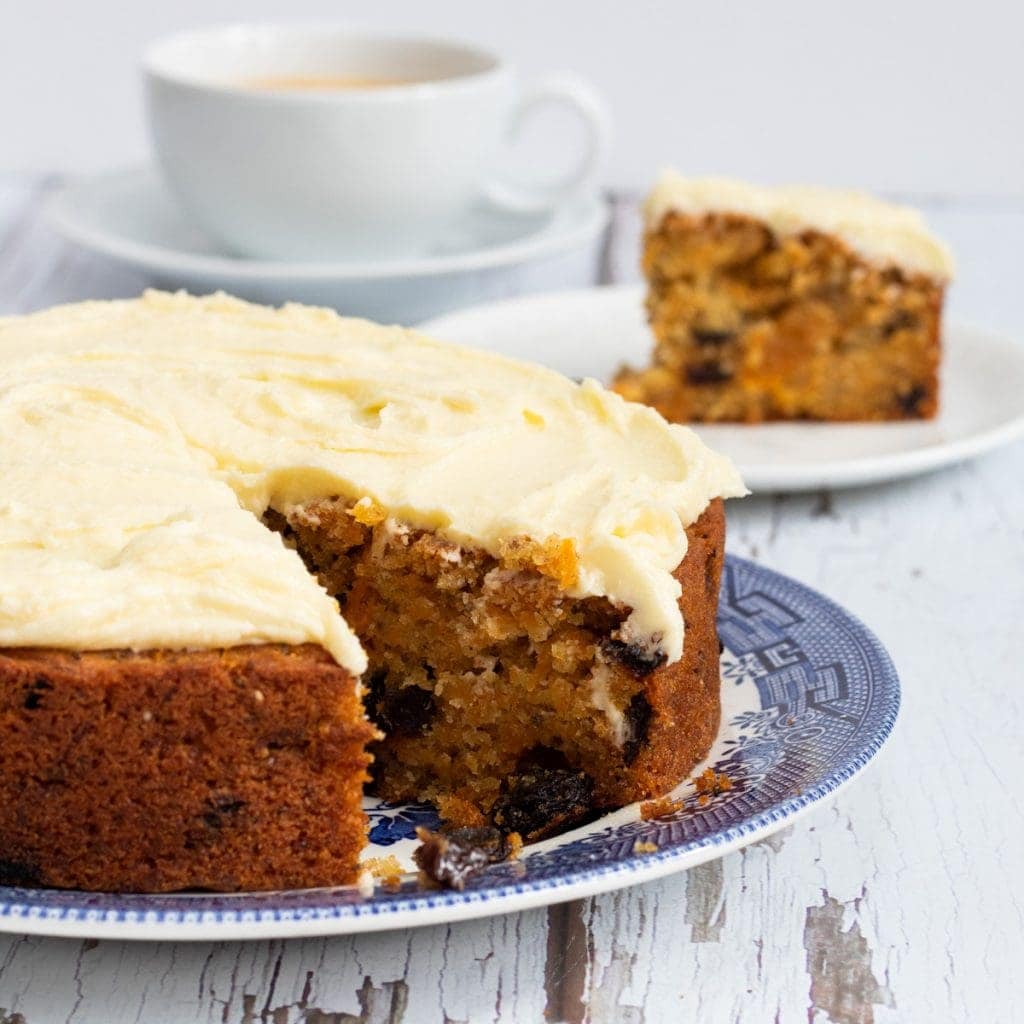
[{"x1": 0, "y1": 0, "x2": 1024, "y2": 197}]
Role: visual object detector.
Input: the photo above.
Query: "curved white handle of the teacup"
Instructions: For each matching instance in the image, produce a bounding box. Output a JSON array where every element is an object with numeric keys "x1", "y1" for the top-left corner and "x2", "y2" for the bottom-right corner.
[{"x1": 483, "y1": 73, "x2": 611, "y2": 213}]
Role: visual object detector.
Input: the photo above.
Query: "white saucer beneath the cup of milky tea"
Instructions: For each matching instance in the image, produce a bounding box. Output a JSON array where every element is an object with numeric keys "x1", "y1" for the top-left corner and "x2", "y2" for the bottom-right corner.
[{"x1": 47, "y1": 167, "x2": 608, "y2": 324}]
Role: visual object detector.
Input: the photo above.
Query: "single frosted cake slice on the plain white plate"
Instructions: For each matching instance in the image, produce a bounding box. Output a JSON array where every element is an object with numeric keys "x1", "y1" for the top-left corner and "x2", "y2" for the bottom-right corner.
[{"x1": 612, "y1": 172, "x2": 952, "y2": 423}]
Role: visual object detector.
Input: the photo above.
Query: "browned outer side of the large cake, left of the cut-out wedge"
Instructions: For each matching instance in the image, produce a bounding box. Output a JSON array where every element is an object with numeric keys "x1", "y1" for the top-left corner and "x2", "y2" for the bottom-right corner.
[{"x1": 0, "y1": 645, "x2": 373, "y2": 892}]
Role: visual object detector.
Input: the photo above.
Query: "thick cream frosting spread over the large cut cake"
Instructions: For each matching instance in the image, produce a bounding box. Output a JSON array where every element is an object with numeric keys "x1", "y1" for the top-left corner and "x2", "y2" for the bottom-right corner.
[{"x1": 0, "y1": 292, "x2": 745, "y2": 673}]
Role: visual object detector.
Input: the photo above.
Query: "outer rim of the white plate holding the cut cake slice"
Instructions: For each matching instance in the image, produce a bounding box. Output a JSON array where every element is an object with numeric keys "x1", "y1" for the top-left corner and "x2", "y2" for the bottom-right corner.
[{"x1": 416, "y1": 282, "x2": 1024, "y2": 494}]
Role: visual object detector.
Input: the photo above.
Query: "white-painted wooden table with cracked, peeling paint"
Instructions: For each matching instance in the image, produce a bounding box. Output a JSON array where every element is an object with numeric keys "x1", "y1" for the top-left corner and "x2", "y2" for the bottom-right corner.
[{"x1": 0, "y1": 179, "x2": 1024, "y2": 1024}]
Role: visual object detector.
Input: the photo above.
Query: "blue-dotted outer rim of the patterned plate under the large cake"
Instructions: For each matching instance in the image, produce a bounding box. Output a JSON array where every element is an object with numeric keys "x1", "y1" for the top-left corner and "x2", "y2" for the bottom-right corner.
[{"x1": 0, "y1": 554, "x2": 901, "y2": 941}]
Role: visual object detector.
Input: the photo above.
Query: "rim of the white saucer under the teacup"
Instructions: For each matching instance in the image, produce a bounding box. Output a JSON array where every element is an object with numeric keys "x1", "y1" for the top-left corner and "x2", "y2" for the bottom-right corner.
[{"x1": 42, "y1": 164, "x2": 611, "y2": 284}]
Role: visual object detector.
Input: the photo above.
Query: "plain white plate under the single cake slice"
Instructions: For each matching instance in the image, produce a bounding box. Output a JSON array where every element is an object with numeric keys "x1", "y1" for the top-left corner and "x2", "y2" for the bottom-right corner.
[{"x1": 421, "y1": 285, "x2": 1024, "y2": 490}]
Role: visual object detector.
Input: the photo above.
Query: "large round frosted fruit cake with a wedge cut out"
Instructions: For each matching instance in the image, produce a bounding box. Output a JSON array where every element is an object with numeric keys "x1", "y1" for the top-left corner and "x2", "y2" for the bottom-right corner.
[{"x1": 0, "y1": 292, "x2": 744, "y2": 891}]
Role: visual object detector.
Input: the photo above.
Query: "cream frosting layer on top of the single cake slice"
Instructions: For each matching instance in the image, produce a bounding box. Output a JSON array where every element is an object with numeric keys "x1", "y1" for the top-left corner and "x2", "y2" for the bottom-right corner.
[{"x1": 644, "y1": 171, "x2": 953, "y2": 281}]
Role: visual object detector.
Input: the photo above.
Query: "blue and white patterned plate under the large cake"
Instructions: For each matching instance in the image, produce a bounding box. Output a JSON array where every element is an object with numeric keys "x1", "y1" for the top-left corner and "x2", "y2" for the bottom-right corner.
[{"x1": 0, "y1": 556, "x2": 899, "y2": 940}]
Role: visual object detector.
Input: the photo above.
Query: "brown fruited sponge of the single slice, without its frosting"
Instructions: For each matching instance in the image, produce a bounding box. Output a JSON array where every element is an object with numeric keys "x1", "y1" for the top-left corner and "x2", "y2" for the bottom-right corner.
[{"x1": 612, "y1": 213, "x2": 944, "y2": 423}]
